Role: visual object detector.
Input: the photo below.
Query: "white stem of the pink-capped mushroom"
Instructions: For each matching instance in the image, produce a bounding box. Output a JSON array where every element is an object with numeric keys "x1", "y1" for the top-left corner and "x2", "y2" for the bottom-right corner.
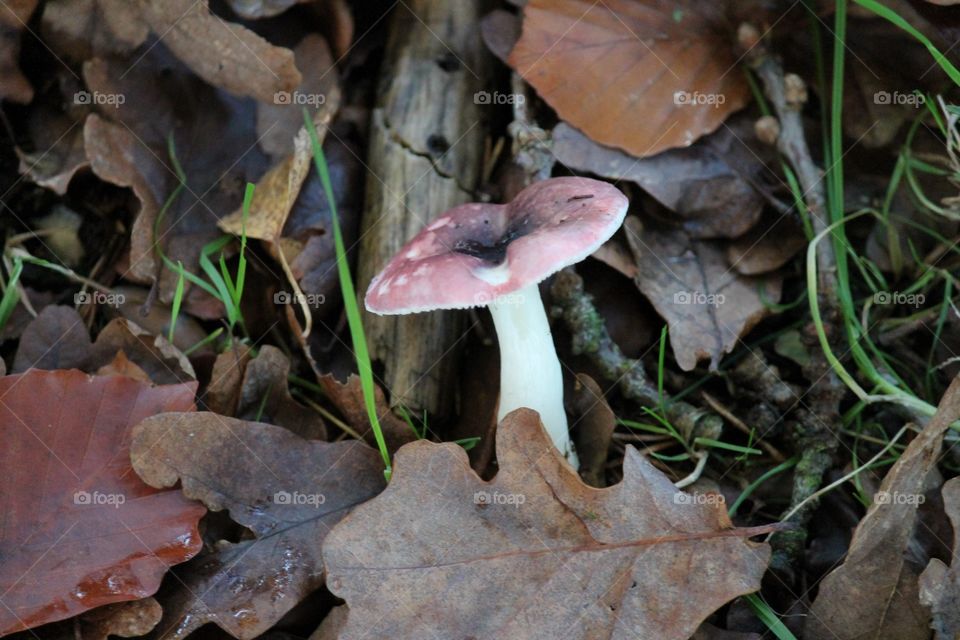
[{"x1": 489, "y1": 284, "x2": 579, "y2": 469}]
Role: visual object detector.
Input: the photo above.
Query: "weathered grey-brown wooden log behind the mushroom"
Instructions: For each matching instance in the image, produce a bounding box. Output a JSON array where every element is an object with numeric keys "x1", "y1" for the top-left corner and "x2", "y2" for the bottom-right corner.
[{"x1": 358, "y1": 0, "x2": 495, "y2": 415}]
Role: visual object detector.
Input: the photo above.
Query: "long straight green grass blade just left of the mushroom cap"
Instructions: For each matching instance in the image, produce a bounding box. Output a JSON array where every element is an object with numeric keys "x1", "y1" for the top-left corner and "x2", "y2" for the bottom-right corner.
[{"x1": 303, "y1": 109, "x2": 392, "y2": 480}]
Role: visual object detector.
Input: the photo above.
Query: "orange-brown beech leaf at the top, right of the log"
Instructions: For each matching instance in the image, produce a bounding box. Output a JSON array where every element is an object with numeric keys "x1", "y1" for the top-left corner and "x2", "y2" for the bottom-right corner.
[{"x1": 510, "y1": 0, "x2": 750, "y2": 157}]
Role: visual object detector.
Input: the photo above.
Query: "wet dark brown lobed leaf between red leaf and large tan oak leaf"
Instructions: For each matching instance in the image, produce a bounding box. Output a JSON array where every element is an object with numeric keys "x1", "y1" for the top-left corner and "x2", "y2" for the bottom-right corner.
[{"x1": 131, "y1": 413, "x2": 384, "y2": 640}]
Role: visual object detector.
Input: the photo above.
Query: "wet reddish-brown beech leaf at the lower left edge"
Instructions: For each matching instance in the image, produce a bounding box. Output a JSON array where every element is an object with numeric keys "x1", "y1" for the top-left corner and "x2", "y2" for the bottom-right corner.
[{"x1": 0, "y1": 370, "x2": 206, "y2": 635}]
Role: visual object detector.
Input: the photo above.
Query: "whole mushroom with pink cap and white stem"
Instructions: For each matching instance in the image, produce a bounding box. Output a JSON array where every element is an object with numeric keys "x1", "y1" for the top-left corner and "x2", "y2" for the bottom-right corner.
[{"x1": 365, "y1": 178, "x2": 628, "y2": 468}]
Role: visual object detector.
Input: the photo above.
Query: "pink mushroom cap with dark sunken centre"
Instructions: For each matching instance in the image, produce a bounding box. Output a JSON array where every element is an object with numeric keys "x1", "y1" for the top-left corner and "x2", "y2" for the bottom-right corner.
[{"x1": 365, "y1": 178, "x2": 628, "y2": 314}]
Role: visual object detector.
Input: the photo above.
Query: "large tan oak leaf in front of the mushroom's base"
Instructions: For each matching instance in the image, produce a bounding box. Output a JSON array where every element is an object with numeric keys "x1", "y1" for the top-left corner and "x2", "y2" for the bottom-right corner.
[{"x1": 323, "y1": 409, "x2": 770, "y2": 640}]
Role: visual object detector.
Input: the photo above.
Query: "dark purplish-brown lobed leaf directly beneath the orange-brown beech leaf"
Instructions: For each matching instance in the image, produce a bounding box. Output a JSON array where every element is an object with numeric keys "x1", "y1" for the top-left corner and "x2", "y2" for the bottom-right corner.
[{"x1": 553, "y1": 118, "x2": 767, "y2": 238}]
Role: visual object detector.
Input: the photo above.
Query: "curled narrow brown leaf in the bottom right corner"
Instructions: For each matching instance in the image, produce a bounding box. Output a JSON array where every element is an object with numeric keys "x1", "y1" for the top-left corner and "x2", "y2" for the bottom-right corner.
[{"x1": 804, "y1": 378, "x2": 960, "y2": 640}]
